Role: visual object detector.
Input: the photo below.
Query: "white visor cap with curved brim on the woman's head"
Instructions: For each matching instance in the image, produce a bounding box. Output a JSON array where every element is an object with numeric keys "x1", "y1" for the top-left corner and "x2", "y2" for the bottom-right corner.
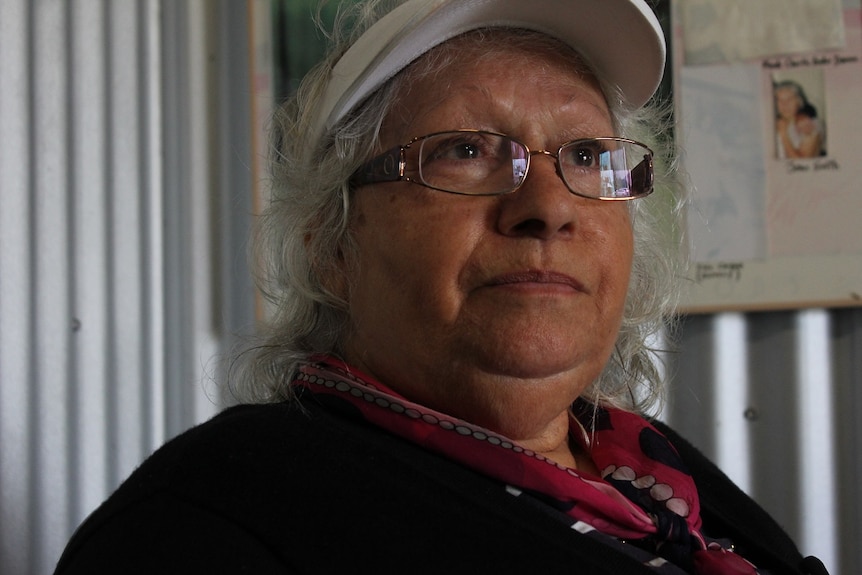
[{"x1": 315, "y1": 0, "x2": 666, "y2": 146}]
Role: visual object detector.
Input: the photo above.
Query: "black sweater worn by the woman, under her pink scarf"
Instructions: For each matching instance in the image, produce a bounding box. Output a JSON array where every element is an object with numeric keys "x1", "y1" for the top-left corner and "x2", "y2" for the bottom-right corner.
[{"x1": 56, "y1": 401, "x2": 825, "y2": 575}]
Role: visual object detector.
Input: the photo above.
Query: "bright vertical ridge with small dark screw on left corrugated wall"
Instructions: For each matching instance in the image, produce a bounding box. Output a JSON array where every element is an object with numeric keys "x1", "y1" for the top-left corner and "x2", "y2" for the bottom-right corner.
[{"x1": 69, "y1": 0, "x2": 111, "y2": 523}]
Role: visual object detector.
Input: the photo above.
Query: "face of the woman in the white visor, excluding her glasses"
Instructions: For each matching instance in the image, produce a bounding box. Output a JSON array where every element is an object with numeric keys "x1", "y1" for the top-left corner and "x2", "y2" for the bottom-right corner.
[{"x1": 346, "y1": 38, "x2": 632, "y2": 439}]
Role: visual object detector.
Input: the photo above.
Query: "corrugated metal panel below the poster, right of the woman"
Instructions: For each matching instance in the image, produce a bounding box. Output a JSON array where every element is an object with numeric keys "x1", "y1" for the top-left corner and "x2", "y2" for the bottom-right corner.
[{"x1": 665, "y1": 309, "x2": 862, "y2": 573}]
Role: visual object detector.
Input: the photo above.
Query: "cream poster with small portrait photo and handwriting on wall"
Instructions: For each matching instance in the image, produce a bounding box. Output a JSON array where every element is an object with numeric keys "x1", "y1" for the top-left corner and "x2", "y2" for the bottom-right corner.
[{"x1": 673, "y1": 0, "x2": 862, "y2": 312}]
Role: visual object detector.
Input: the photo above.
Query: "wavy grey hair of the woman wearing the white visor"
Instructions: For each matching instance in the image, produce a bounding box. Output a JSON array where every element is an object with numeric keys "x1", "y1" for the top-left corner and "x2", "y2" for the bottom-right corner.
[{"x1": 230, "y1": 0, "x2": 685, "y2": 413}]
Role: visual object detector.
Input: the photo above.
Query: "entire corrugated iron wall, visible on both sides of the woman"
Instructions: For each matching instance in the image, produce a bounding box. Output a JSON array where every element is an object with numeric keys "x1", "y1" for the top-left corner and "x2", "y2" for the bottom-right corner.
[{"x1": 0, "y1": 0, "x2": 862, "y2": 575}]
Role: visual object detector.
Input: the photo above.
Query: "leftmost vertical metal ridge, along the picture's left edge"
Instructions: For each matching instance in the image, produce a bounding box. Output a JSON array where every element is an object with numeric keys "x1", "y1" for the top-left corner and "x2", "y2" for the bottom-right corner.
[{"x1": 0, "y1": 0, "x2": 36, "y2": 573}]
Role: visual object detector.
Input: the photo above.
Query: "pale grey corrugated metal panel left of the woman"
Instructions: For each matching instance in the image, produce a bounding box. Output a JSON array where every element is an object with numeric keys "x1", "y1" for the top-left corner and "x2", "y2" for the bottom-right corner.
[{"x1": 0, "y1": 0, "x2": 253, "y2": 575}]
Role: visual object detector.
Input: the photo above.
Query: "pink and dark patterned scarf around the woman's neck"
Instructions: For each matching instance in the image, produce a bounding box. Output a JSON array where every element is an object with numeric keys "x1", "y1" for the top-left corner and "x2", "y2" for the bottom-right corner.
[{"x1": 293, "y1": 357, "x2": 758, "y2": 575}]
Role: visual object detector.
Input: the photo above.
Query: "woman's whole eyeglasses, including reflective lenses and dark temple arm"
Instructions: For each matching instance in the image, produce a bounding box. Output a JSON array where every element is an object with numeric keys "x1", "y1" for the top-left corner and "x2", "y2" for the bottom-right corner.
[{"x1": 350, "y1": 130, "x2": 653, "y2": 200}]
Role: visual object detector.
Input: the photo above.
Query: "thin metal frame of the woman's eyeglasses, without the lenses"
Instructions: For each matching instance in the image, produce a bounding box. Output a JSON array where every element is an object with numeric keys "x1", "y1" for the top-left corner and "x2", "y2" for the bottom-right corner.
[{"x1": 348, "y1": 129, "x2": 655, "y2": 201}]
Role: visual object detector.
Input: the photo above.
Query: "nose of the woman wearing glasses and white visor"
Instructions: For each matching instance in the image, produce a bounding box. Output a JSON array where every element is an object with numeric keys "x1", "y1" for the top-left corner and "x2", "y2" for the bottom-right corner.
[{"x1": 497, "y1": 151, "x2": 589, "y2": 239}]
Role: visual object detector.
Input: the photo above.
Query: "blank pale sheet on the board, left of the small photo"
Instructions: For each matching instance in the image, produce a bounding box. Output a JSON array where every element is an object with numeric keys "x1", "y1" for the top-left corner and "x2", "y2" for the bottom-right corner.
[{"x1": 679, "y1": 65, "x2": 767, "y2": 262}]
